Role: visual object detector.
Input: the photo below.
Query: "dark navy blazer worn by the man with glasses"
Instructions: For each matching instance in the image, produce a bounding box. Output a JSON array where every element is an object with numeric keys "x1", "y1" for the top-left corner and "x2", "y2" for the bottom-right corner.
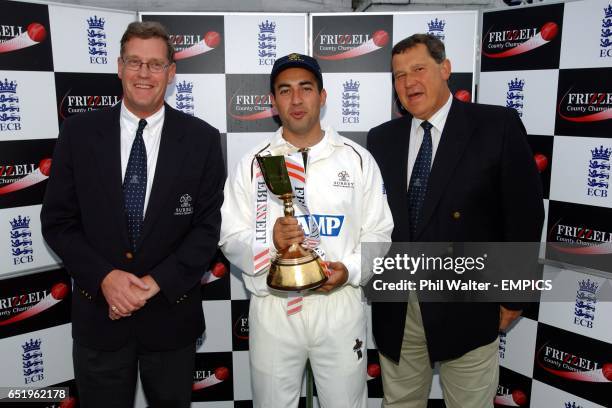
[{"x1": 41, "y1": 104, "x2": 225, "y2": 350}]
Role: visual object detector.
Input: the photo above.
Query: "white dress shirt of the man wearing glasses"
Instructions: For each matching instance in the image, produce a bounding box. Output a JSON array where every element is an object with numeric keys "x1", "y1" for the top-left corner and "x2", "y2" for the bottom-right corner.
[{"x1": 120, "y1": 103, "x2": 166, "y2": 217}]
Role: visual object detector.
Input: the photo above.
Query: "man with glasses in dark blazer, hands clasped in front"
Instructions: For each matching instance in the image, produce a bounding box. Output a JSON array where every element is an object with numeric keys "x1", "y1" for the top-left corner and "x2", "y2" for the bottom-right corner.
[{"x1": 41, "y1": 22, "x2": 225, "y2": 407}]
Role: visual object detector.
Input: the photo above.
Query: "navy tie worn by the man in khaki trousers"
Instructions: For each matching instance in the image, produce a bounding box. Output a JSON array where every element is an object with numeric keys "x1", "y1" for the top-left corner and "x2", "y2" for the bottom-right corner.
[{"x1": 408, "y1": 121, "x2": 433, "y2": 238}]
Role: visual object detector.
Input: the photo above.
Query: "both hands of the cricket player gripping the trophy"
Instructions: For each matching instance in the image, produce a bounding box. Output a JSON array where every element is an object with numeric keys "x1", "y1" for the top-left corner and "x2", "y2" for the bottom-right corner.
[{"x1": 272, "y1": 217, "x2": 348, "y2": 292}]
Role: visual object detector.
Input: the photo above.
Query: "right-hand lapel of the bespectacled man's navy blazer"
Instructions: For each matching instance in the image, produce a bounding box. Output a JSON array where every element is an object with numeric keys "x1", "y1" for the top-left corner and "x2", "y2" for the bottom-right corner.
[{"x1": 136, "y1": 104, "x2": 188, "y2": 248}]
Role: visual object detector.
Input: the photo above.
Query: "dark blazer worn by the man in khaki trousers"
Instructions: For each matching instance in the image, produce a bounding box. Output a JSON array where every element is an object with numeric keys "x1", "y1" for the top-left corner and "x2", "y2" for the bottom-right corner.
[{"x1": 368, "y1": 100, "x2": 544, "y2": 361}]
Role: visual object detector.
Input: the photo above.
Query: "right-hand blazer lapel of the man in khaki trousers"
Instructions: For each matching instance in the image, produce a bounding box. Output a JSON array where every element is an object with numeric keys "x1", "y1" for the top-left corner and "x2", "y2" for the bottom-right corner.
[{"x1": 413, "y1": 100, "x2": 472, "y2": 240}]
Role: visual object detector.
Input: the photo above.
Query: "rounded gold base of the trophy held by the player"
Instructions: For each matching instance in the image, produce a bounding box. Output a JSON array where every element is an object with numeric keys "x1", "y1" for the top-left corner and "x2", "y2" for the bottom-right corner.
[{"x1": 267, "y1": 246, "x2": 327, "y2": 292}]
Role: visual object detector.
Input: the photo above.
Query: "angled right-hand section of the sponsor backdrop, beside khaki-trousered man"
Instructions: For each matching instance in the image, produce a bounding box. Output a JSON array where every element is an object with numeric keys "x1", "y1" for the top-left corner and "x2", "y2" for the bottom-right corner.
[{"x1": 478, "y1": 0, "x2": 612, "y2": 408}]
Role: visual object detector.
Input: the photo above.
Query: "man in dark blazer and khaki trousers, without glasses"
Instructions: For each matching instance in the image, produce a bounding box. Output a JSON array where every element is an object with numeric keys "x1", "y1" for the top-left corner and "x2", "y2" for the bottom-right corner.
[{"x1": 368, "y1": 34, "x2": 544, "y2": 408}]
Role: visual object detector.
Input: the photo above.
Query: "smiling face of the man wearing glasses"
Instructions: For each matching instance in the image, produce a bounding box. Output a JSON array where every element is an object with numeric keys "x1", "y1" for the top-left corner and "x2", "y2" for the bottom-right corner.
[{"x1": 117, "y1": 37, "x2": 176, "y2": 118}]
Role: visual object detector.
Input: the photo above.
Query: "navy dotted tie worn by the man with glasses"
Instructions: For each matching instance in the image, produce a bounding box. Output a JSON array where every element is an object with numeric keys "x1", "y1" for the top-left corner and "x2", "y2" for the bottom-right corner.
[{"x1": 123, "y1": 119, "x2": 147, "y2": 250}]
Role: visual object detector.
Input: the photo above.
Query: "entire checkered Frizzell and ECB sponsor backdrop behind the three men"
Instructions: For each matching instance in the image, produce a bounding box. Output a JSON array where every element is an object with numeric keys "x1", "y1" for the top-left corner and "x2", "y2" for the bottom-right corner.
[{"x1": 0, "y1": 0, "x2": 612, "y2": 408}]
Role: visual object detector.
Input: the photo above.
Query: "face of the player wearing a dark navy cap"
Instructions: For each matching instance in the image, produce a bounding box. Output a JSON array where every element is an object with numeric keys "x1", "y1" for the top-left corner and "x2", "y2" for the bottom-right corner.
[{"x1": 272, "y1": 68, "x2": 327, "y2": 146}]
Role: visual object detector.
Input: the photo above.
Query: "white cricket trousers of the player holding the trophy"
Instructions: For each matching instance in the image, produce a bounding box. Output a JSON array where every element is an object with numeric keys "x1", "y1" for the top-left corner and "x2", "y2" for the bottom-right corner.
[{"x1": 249, "y1": 286, "x2": 368, "y2": 408}]
